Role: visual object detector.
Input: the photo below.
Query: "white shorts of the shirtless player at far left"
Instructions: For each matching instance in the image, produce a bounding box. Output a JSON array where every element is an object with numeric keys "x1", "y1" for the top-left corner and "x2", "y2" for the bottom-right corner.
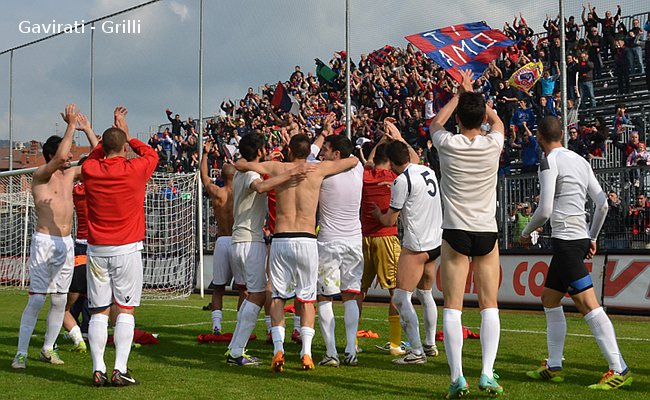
[{"x1": 27, "y1": 232, "x2": 74, "y2": 294}]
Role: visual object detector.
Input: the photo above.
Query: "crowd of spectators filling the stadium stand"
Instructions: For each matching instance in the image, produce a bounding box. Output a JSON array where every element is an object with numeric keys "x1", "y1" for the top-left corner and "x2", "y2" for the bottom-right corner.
[{"x1": 150, "y1": 5, "x2": 650, "y2": 250}]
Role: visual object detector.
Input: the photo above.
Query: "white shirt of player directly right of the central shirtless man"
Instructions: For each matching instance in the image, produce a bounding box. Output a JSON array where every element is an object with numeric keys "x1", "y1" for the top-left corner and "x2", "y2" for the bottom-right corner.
[{"x1": 318, "y1": 163, "x2": 363, "y2": 242}]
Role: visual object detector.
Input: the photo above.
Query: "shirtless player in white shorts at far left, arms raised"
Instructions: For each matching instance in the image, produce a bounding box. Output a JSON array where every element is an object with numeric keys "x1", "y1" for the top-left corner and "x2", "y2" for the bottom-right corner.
[{"x1": 11, "y1": 104, "x2": 95, "y2": 369}]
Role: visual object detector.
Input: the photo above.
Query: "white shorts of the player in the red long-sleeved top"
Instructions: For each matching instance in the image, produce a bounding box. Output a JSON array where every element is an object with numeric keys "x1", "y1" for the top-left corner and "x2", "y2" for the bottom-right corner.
[{"x1": 86, "y1": 245, "x2": 142, "y2": 310}]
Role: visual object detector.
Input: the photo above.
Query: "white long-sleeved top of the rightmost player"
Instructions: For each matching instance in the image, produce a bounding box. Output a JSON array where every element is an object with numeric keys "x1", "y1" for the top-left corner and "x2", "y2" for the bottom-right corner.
[{"x1": 522, "y1": 147, "x2": 607, "y2": 240}]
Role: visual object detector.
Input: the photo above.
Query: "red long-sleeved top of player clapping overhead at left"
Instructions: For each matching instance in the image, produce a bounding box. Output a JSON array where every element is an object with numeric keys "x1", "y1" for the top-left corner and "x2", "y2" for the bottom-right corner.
[{"x1": 81, "y1": 139, "x2": 158, "y2": 246}]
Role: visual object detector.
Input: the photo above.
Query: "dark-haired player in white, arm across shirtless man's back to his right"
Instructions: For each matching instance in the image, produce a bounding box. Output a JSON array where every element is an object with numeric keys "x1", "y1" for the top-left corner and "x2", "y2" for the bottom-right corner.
[{"x1": 226, "y1": 133, "x2": 311, "y2": 366}]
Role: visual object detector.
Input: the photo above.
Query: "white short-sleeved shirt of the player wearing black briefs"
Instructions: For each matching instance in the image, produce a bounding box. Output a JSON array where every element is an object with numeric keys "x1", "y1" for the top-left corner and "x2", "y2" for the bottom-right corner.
[{"x1": 431, "y1": 129, "x2": 503, "y2": 232}]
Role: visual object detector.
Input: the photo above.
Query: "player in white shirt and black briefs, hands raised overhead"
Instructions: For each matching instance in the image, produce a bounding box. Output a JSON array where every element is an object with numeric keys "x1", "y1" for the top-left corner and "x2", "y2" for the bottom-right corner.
[{"x1": 429, "y1": 70, "x2": 504, "y2": 398}]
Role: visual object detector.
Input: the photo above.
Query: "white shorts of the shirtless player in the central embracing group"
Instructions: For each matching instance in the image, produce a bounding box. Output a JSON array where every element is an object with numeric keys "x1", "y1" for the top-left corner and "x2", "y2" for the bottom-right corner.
[{"x1": 269, "y1": 234, "x2": 318, "y2": 303}]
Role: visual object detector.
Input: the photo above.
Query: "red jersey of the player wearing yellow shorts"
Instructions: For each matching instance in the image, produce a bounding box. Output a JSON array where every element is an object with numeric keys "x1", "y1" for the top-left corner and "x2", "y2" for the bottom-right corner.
[{"x1": 361, "y1": 165, "x2": 397, "y2": 236}]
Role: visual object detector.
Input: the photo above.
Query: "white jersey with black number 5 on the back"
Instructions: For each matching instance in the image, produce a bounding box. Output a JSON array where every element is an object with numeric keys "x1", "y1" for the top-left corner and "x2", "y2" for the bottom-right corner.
[{"x1": 390, "y1": 164, "x2": 442, "y2": 251}]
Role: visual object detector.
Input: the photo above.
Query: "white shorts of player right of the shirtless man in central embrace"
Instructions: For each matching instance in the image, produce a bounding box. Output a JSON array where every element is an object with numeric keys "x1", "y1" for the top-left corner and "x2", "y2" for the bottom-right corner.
[{"x1": 318, "y1": 239, "x2": 363, "y2": 296}]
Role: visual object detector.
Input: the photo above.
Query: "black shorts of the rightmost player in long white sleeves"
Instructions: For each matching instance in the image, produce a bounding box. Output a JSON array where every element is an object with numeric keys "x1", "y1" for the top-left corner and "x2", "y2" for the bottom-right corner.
[{"x1": 544, "y1": 238, "x2": 594, "y2": 296}]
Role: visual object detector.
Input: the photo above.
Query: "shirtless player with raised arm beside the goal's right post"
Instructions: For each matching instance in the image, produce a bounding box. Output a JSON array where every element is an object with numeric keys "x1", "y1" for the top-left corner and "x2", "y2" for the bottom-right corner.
[{"x1": 199, "y1": 140, "x2": 238, "y2": 335}]
